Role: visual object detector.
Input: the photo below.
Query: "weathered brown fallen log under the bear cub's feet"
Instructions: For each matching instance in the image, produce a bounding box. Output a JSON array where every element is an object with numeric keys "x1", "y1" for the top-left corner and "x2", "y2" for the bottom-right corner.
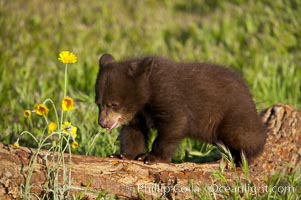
[{"x1": 0, "y1": 104, "x2": 301, "y2": 199}]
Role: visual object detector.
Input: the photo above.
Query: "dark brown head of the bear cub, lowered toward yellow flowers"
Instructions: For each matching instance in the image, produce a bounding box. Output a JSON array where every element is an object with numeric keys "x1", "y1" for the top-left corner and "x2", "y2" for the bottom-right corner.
[{"x1": 95, "y1": 54, "x2": 153, "y2": 130}]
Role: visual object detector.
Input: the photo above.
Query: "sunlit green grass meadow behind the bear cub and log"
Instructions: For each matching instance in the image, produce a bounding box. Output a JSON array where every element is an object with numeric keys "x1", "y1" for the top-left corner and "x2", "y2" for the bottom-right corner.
[{"x1": 0, "y1": 0, "x2": 301, "y2": 199}]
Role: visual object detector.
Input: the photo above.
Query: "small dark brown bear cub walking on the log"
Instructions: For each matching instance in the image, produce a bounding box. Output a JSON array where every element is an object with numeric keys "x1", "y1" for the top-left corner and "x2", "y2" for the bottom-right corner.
[{"x1": 95, "y1": 54, "x2": 266, "y2": 162}]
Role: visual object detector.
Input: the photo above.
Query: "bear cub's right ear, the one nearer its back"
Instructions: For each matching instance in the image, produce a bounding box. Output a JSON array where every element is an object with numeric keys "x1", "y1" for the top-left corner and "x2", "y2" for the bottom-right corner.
[{"x1": 128, "y1": 57, "x2": 154, "y2": 76}]
